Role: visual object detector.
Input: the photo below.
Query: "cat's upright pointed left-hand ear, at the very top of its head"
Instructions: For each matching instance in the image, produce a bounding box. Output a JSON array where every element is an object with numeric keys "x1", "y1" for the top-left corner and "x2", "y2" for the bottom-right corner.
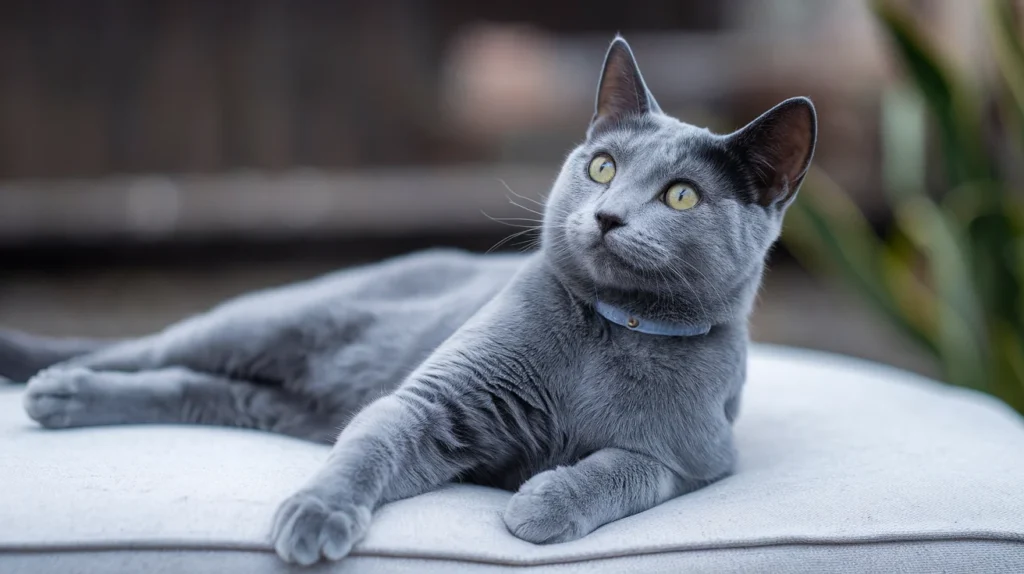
[{"x1": 587, "y1": 36, "x2": 660, "y2": 135}]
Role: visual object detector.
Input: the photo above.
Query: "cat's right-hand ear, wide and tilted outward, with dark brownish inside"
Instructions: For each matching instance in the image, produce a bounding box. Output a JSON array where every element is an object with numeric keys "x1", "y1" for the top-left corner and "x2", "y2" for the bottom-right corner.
[{"x1": 728, "y1": 97, "x2": 818, "y2": 207}]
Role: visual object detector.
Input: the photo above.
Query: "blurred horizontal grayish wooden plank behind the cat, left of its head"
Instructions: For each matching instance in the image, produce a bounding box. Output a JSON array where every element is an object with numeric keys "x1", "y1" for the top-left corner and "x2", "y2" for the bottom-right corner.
[{"x1": 0, "y1": 166, "x2": 557, "y2": 244}]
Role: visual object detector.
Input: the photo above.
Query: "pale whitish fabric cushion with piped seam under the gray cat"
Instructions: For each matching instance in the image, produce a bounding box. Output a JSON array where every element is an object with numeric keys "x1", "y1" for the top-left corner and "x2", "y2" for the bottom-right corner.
[{"x1": 0, "y1": 346, "x2": 1024, "y2": 574}]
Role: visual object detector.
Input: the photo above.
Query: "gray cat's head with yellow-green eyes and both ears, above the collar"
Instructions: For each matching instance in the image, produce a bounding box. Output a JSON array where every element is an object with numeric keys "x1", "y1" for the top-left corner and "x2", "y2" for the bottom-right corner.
[{"x1": 542, "y1": 38, "x2": 816, "y2": 322}]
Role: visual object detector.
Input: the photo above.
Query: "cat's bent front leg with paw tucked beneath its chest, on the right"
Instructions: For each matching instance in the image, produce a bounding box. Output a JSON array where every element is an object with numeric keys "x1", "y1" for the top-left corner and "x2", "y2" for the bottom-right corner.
[{"x1": 504, "y1": 448, "x2": 724, "y2": 544}]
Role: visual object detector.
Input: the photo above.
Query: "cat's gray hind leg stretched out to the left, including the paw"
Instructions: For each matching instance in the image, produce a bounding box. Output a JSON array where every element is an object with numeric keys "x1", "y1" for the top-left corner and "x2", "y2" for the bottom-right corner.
[{"x1": 24, "y1": 366, "x2": 348, "y2": 443}]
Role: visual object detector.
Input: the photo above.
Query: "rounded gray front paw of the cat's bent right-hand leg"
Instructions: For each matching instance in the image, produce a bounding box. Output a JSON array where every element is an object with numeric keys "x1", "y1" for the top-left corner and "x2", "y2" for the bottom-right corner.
[{"x1": 504, "y1": 469, "x2": 592, "y2": 544}]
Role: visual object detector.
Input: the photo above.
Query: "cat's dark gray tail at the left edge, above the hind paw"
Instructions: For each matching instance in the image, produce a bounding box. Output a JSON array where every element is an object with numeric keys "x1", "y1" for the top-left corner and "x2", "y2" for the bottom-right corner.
[{"x1": 0, "y1": 328, "x2": 115, "y2": 383}]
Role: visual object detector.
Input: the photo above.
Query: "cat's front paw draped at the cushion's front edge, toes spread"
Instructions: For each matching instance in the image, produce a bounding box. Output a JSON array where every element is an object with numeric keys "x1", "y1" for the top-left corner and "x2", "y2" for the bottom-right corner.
[{"x1": 270, "y1": 491, "x2": 370, "y2": 566}]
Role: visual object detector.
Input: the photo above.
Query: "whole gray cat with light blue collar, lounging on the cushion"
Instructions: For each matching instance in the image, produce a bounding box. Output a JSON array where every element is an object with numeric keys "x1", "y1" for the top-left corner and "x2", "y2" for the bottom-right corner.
[{"x1": 0, "y1": 38, "x2": 816, "y2": 564}]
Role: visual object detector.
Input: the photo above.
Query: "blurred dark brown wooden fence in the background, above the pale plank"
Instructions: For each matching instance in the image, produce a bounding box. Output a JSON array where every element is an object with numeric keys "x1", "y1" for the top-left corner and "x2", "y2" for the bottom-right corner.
[{"x1": 0, "y1": 0, "x2": 720, "y2": 178}]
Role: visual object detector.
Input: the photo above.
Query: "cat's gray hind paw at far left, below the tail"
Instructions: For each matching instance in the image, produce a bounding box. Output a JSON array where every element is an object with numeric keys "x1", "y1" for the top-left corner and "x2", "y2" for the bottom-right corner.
[{"x1": 23, "y1": 367, "x2": 94, "y2": 429}]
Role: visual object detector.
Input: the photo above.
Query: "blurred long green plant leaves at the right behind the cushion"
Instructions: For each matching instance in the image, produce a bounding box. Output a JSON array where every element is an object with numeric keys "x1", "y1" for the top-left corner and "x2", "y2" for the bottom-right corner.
[{"x1": 784, "y1": 0, "x2": 1024, "y2": 413}]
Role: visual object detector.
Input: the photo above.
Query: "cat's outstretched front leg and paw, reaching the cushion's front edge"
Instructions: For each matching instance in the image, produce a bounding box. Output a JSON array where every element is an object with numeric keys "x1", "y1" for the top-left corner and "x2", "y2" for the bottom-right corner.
[{"x1": 271, "y1": 385, "x2": 509, "y2": 565}]
